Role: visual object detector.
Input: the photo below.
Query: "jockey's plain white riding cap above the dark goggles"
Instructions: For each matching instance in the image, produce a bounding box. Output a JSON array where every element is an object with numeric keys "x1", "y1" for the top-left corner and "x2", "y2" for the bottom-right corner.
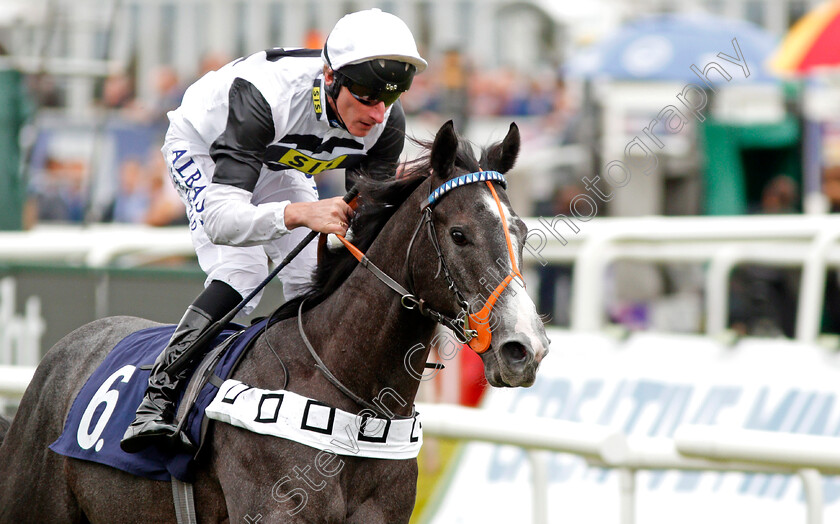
[{"x1": 321, "y1": 9, "x2": 428, "y2": 73}]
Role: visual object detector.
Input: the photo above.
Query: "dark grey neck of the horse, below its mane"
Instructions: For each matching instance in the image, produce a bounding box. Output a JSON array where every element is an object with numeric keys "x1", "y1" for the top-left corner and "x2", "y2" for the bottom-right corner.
[{"x1": 305, "y1": 188, "x2": 435, "y2": 414}]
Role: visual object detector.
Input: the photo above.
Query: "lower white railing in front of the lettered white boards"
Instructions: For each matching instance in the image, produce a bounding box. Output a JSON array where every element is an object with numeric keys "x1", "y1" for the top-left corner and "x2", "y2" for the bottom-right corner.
[{"x1": 417, "y1": 404, "x2": 840, "y2": 524}]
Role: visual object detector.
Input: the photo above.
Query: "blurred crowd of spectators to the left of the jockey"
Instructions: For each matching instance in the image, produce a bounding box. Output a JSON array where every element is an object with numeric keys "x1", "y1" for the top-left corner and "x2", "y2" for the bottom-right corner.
[{"x1": 24, "y1": 54, "x2": 229, "y2": 228}]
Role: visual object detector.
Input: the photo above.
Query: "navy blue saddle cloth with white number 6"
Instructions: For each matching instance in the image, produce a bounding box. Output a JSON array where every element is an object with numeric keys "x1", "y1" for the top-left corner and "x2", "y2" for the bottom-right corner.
[{"x1": 50, "y1": 319, "x2": 268, "y2": 482}]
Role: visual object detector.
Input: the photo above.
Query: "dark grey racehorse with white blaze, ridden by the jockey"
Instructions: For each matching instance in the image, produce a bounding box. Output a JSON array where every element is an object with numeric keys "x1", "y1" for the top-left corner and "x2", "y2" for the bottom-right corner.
[{"x1": 0, "y1": 122, "x2": 548, "y2": 524}]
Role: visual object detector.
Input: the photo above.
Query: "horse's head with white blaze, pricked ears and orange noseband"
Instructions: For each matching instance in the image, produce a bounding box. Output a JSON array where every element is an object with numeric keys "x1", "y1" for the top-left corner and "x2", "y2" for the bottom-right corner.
[{"x1": 412, "y1": 122, "x2": 549, "y2": 387}]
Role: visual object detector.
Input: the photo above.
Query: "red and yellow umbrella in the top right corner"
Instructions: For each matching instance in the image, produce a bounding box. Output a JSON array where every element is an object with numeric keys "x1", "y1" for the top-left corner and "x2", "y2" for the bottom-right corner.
[{"x1": 770, "y1": 0, "x2": 840, "y2": 74}]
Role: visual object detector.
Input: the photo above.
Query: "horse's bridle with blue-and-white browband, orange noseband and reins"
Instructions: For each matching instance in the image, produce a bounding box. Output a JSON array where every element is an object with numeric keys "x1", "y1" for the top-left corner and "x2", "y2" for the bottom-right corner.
[{"x1": 336, "y1": 171, "x2": 525, "y2": 353}]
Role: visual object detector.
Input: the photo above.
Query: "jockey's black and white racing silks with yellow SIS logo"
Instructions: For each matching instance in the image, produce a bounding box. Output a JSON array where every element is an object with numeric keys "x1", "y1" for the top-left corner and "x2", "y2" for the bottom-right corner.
[{"x1": 163, "y1": 49, "x2": 405, "y2": 246}]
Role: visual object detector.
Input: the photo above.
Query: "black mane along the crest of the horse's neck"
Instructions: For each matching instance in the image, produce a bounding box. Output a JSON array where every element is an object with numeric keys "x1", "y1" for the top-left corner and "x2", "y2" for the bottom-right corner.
[{"x1": 272, "y1": 133, "x2": 480, "y2": 322}]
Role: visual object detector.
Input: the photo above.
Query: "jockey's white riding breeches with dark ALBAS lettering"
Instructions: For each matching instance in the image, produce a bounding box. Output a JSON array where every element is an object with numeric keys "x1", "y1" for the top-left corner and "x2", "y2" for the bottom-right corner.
[{"x1": 161, "y1": 126, "x2": 318, "y2": 314}]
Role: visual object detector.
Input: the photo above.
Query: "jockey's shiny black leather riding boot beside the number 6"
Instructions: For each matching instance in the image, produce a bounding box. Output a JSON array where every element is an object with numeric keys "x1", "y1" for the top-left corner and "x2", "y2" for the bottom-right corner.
[{"x1": 120, "y1": 305, "x2": 213, "y2": 453}]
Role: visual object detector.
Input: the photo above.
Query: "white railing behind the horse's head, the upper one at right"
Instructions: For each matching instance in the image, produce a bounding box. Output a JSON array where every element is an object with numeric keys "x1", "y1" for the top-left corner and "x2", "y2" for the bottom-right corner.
[{"x1": 525, "y1": 215, "x2": 840, "y2": 342}]
